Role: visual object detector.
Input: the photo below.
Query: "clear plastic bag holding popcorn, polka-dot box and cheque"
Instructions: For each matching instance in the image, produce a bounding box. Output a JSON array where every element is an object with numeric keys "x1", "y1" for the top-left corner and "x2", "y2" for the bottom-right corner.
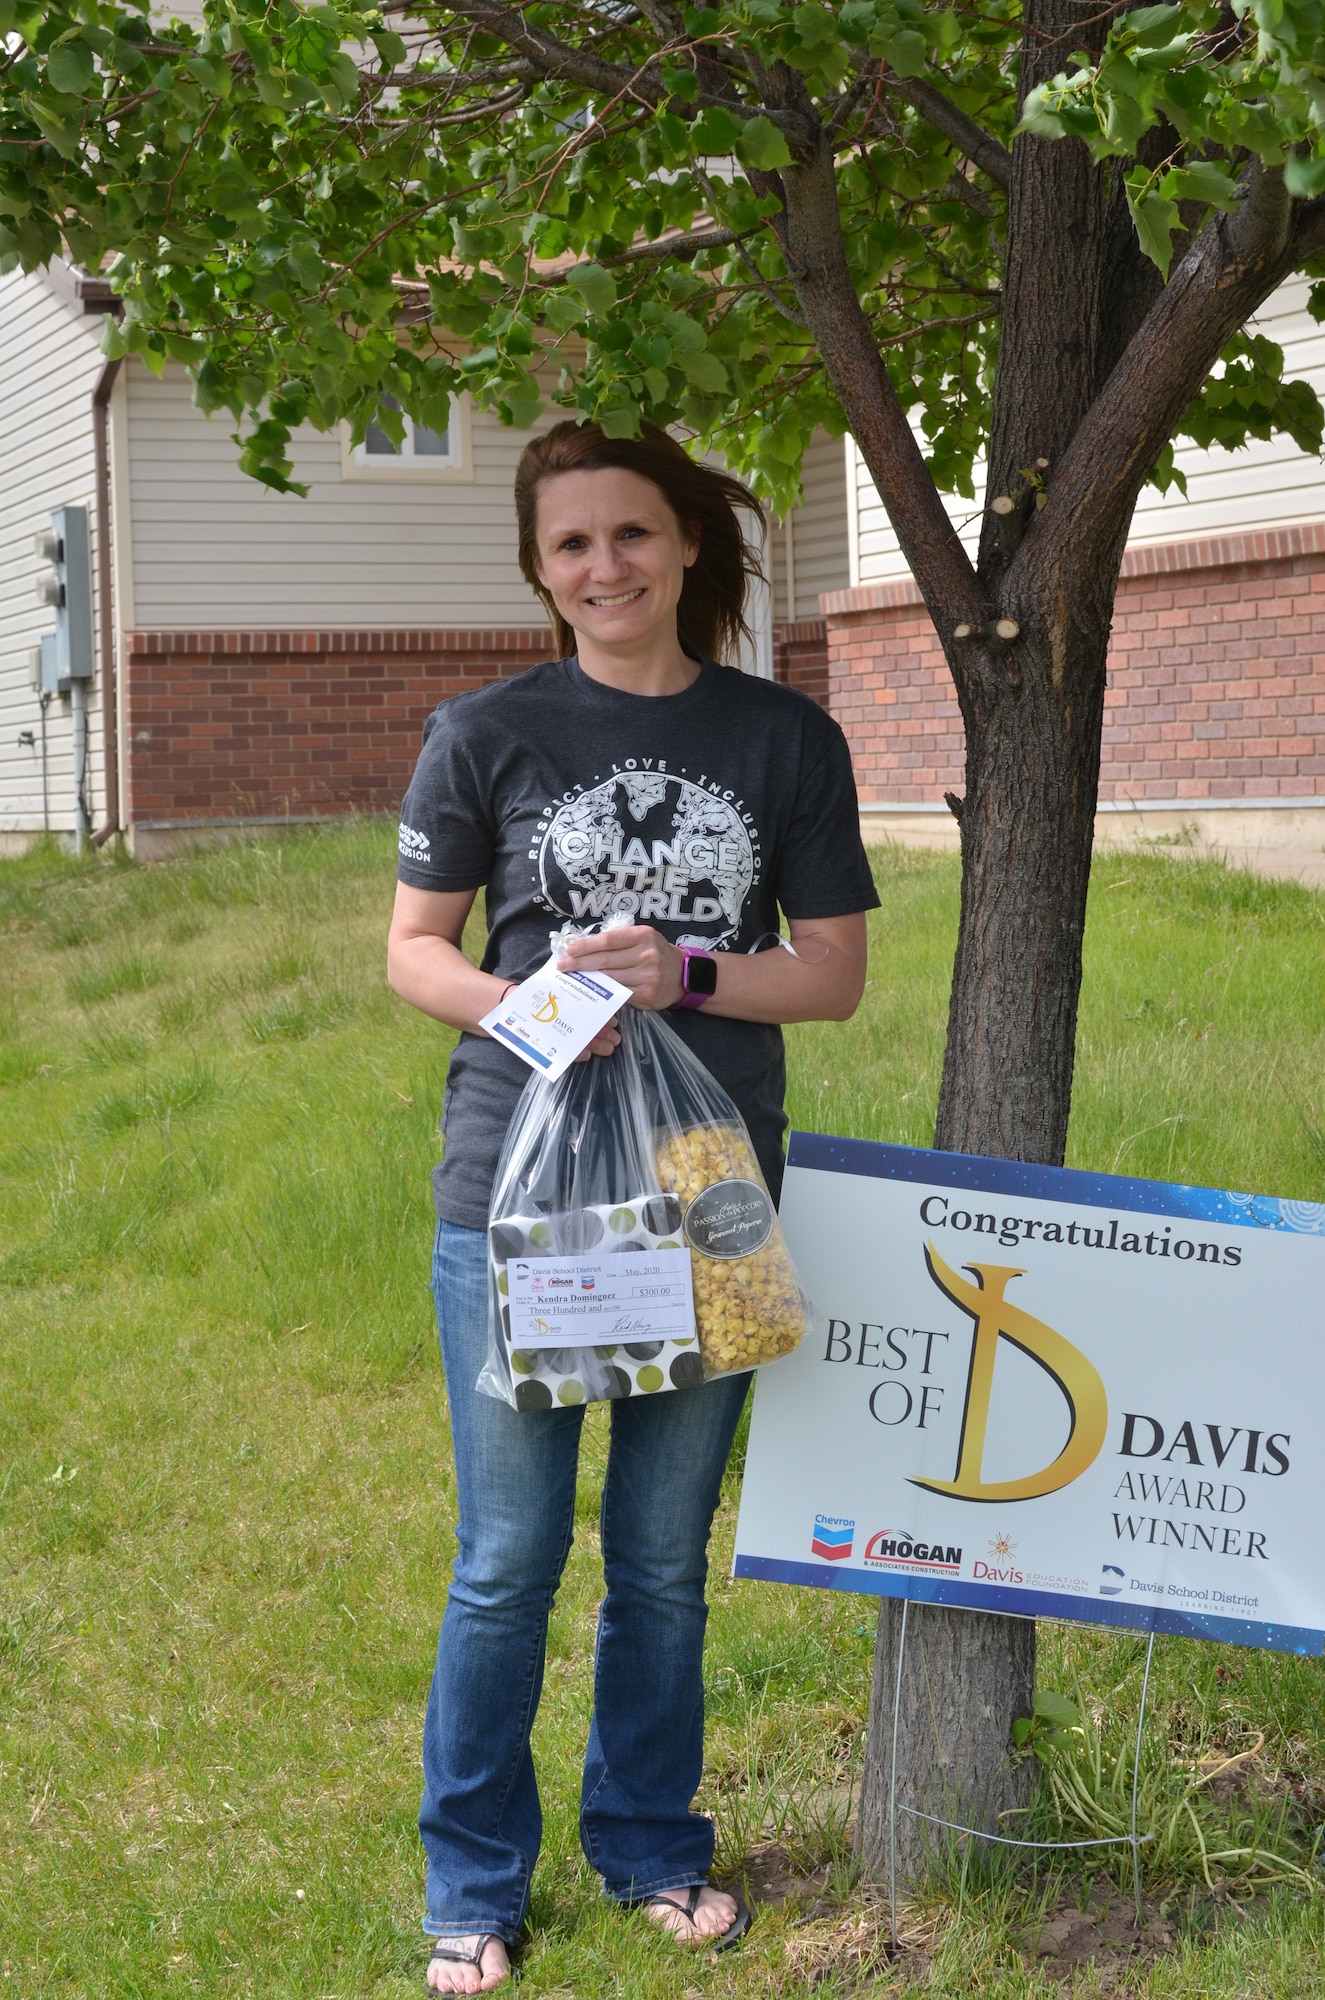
[{"x1": 476, "y1": 1008, "x2": 813, "y2": 1410}]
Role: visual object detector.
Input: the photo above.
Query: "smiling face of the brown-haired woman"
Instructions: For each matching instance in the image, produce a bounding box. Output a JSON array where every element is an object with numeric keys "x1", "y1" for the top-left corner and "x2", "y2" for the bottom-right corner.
[{"x1": 538, "y1": 466, "x2": 699, "y2": 652}]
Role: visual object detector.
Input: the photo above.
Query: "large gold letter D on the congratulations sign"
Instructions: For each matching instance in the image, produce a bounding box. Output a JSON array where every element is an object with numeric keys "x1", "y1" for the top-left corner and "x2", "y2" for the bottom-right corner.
[{"x1": 911, "y1": 1244, "x2": 1109, "y2": 1500}]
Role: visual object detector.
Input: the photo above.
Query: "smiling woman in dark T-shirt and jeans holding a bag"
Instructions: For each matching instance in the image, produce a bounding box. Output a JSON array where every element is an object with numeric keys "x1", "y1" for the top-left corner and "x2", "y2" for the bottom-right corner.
[{"x1": 388, "y1": 422, "x2": 879, "y2": 1992}]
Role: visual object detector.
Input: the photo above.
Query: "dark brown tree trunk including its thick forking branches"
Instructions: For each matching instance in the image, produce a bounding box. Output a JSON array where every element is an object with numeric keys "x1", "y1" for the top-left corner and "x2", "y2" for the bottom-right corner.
[{"x1": 768, "y1": 11, "x2": 1325, "y2": 1882}]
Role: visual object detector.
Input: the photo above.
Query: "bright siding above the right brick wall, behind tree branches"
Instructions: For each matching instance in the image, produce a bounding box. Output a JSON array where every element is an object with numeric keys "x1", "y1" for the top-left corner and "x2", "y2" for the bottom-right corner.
[{"x1": 853, "y1": 278, "x2": 1325, "y2": 584}]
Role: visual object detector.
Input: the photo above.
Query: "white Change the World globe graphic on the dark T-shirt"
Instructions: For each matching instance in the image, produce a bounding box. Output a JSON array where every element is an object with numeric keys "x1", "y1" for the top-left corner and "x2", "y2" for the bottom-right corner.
[{"x1": 536, "y1": 770, "x2": 755, "y2": 950}]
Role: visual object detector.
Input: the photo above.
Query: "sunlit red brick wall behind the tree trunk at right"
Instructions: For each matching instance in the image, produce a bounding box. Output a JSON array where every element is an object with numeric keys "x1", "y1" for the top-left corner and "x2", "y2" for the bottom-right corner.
[{"x1": 823, "y1": 522, "x2": 1325, "y2": 804}]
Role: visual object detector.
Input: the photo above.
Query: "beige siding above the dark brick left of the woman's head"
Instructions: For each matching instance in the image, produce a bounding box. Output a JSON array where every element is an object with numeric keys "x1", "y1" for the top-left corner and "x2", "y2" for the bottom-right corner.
[{"x1": 126, "y1": 364, "x2": 562, "y2": 632}]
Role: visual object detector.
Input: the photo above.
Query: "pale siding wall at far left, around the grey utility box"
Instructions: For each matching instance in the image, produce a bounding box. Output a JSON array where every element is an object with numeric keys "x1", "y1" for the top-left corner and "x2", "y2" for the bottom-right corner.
[{"x1": 0, "y1": 272, "x2": 106, "y2": 834}]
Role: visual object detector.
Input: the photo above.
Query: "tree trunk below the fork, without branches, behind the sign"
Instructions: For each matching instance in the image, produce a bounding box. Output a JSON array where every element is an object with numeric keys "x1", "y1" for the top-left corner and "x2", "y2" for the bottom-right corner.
[{"x1": 859, "y1": 580, "x2": 1111, "y2": 1882}]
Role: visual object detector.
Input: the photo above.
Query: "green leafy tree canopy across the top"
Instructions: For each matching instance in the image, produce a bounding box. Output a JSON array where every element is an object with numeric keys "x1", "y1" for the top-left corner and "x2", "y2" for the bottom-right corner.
[{"x1": 0, "y1": 0, "x2": 1325, "y2": 504}]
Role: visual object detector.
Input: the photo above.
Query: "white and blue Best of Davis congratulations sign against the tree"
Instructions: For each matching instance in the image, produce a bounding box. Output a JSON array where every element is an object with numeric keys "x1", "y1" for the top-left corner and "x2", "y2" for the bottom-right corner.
[{"x1": 735, "y1": 1132, "x2": 1325, "y2": 1654}]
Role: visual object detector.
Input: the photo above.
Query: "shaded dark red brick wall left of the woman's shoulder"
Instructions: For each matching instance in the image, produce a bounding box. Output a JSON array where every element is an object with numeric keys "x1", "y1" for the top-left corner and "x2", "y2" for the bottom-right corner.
[{"x1": 122, "y1": 628, "x2": 552, "y2": 824}]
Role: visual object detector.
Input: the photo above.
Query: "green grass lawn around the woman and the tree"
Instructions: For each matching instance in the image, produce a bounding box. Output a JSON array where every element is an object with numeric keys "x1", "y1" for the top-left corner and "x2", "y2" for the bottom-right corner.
[{"x1": 0, "y1": 824, "x2": 1325, "y2": 2000}]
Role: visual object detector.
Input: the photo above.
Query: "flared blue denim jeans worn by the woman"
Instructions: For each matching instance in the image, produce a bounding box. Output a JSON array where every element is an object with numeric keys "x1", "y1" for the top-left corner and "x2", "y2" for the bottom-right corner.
[{"x1": 418, "y1": 1222, "x2": 751, "y2": 1944}]
